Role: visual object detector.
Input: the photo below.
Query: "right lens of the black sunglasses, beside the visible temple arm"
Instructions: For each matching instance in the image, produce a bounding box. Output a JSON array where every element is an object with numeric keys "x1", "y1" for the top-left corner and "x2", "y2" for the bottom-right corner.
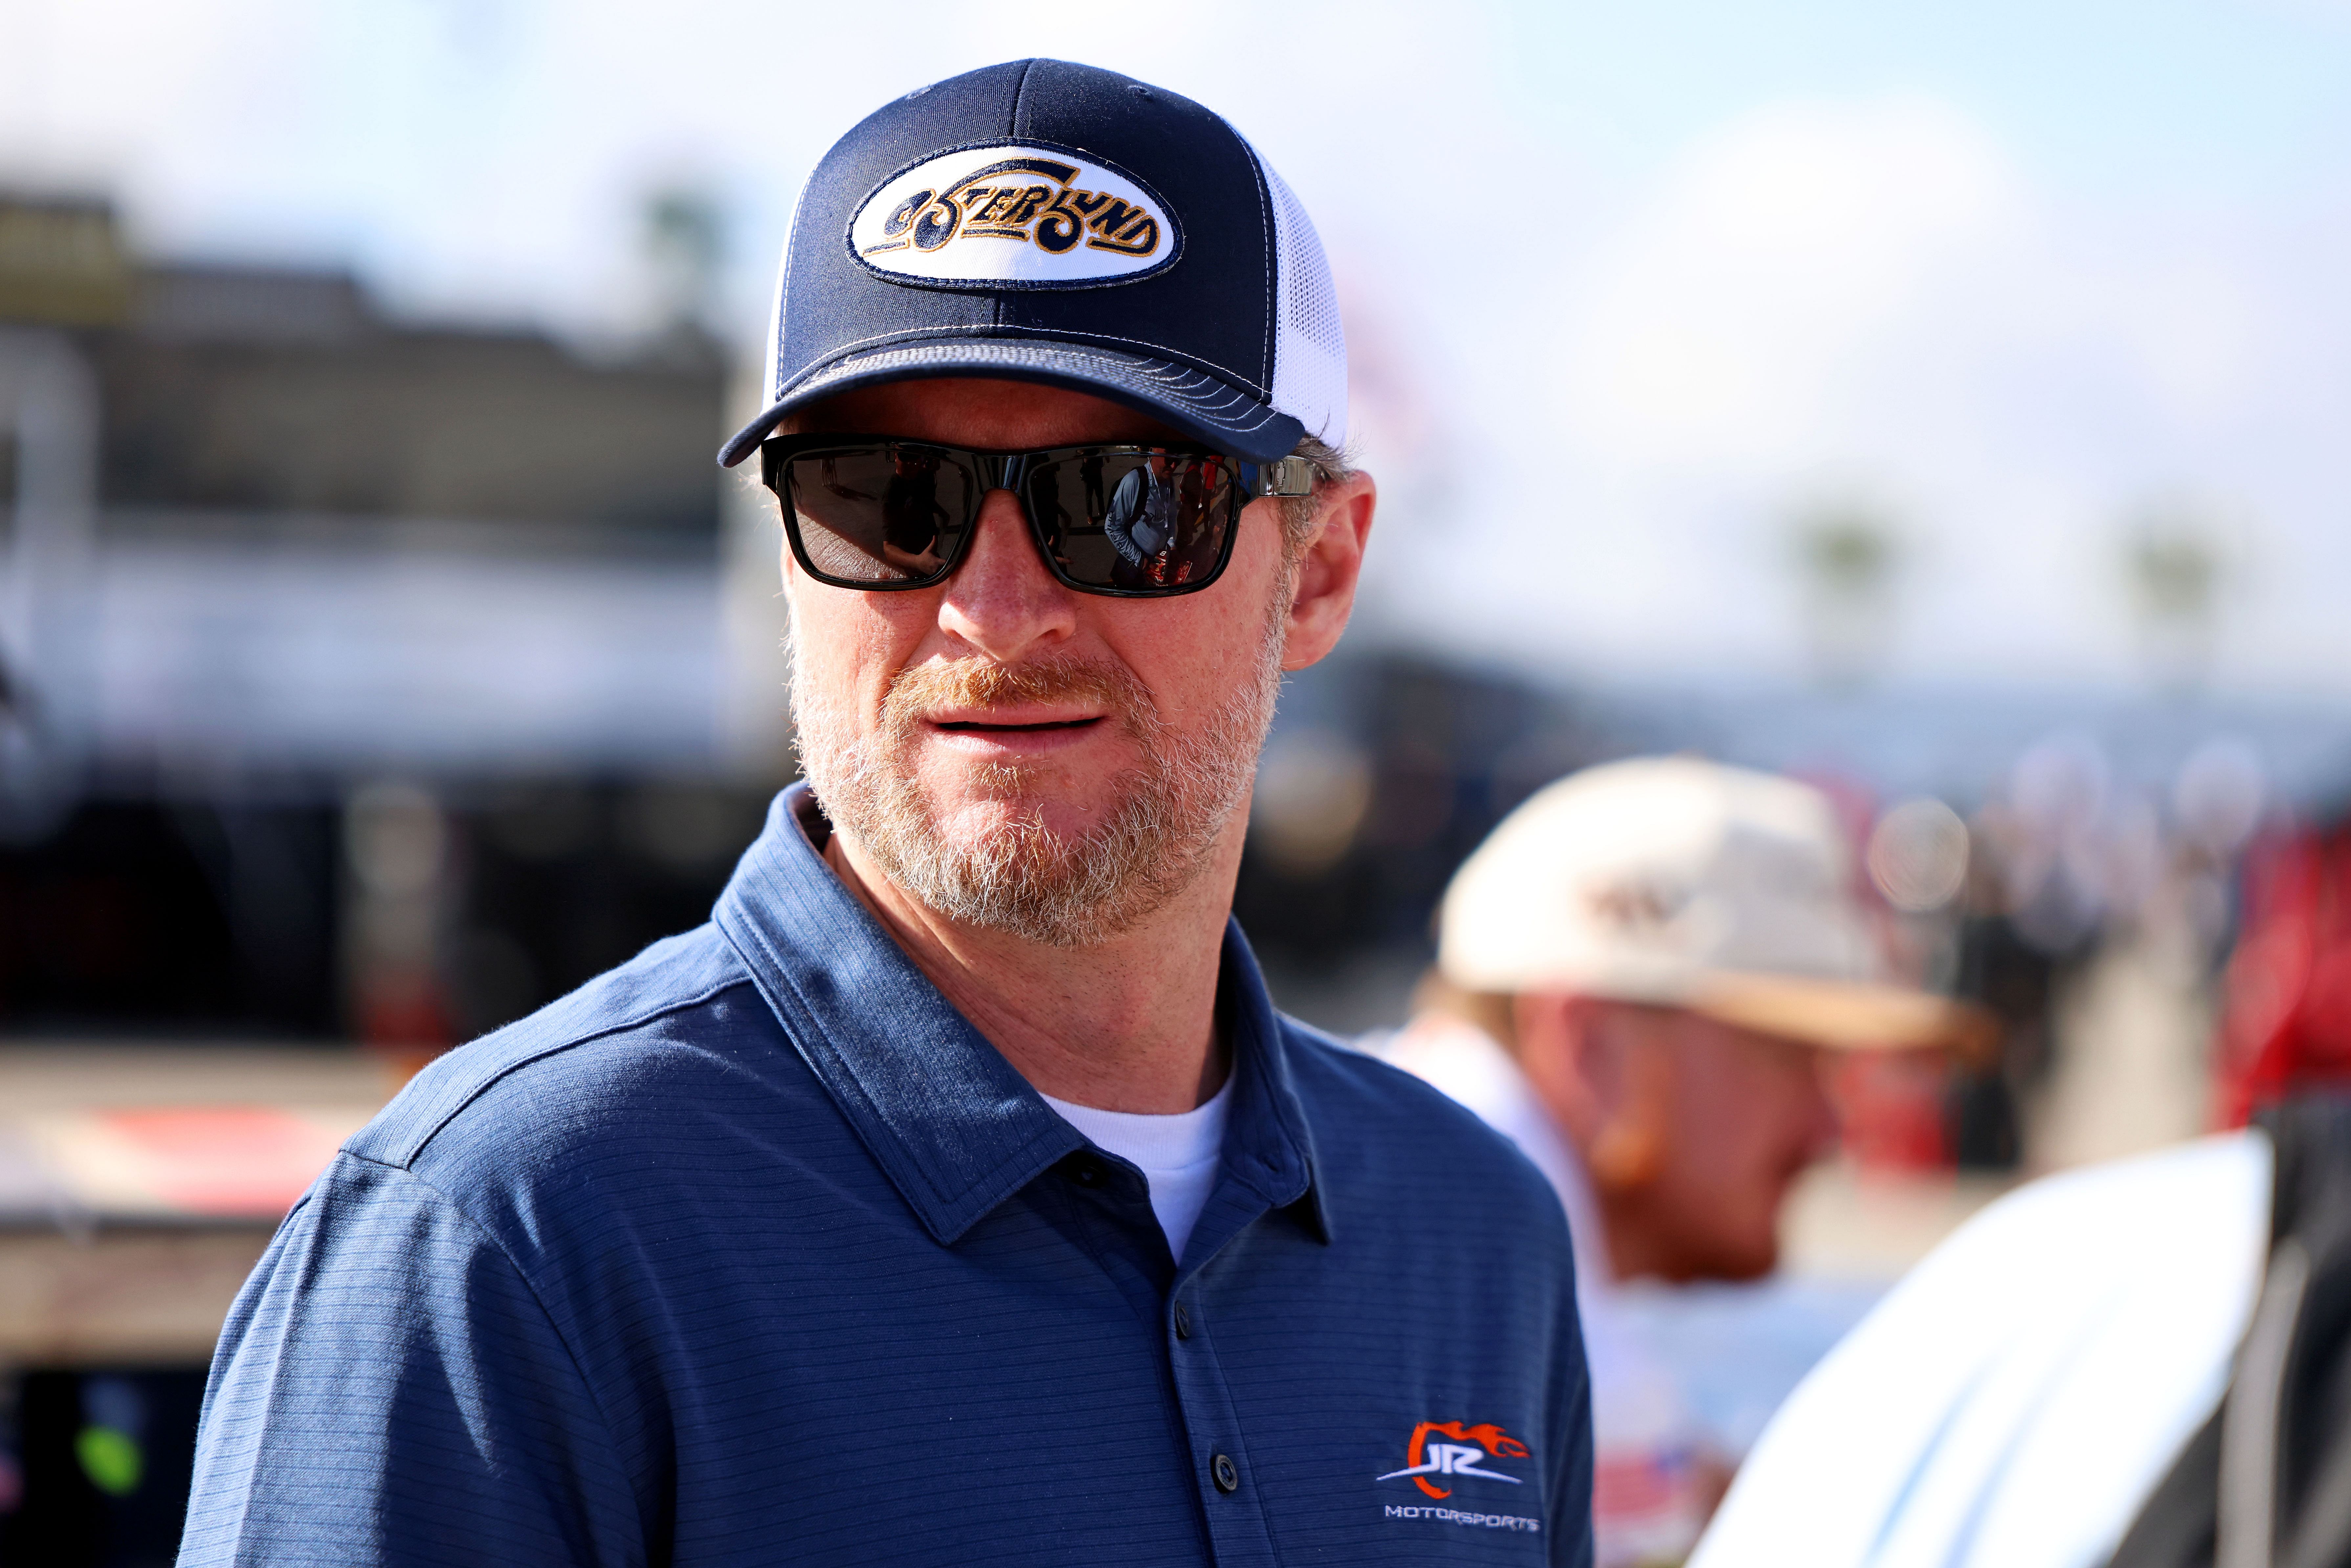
[{"x1": 1027, "y1": 452, "x2": 1241, "y2": 592}]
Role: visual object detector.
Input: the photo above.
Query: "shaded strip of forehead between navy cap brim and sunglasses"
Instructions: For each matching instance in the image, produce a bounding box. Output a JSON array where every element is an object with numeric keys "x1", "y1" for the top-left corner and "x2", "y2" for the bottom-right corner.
[{"x1": 785, "y1": 376, "x2": 1183, "y2": 452}]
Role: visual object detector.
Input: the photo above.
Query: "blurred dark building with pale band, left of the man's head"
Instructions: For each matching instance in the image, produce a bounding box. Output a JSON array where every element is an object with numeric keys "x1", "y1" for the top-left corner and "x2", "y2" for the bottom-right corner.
[{"x1": 0, "y1": 200, "x2": 785, "y2": 1062}]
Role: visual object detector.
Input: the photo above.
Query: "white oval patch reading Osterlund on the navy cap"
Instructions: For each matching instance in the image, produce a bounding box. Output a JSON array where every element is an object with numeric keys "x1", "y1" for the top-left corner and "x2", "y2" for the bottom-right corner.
[{"x1": 849, "y1": 144, "x2": 1183, "y2": 289}]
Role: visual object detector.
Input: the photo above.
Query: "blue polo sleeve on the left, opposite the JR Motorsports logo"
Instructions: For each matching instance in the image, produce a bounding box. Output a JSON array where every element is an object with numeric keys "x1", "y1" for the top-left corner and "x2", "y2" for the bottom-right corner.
[{"x1": 179, "y1": 1154, "x2": 647, "y2": 1568}]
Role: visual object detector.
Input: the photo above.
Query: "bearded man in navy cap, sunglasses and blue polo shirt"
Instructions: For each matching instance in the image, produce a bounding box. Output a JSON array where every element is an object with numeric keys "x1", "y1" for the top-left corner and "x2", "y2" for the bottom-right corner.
[{"x1": 181, "y1": 61, "x2": 1589, "y2": 1568}]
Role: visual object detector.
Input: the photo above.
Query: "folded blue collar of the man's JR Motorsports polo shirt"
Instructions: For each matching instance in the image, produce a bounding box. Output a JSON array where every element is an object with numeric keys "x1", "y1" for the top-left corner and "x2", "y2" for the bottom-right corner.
[{"x1": 712, "y1": 783, "x2": 1328, "y2": 1244}]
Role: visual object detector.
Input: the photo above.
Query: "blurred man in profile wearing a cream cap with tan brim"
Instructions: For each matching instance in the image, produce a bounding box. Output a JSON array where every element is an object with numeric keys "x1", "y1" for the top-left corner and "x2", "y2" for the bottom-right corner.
[{"x1": 1387, "y1": 757, "x2": 1975, "y2": 1566}]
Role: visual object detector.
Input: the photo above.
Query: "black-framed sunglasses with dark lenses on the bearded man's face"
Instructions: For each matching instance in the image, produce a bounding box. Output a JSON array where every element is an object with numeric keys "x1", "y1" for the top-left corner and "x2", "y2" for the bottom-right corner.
[{"x1": 759, "y1": 435, "x2": 1314, "y2": 600}]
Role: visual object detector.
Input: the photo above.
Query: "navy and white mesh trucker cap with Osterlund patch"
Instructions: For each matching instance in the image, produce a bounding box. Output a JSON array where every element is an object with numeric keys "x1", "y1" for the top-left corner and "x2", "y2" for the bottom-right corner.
[{"x1": 720, "y1": 59, "x2": 1347, "y2": 468}]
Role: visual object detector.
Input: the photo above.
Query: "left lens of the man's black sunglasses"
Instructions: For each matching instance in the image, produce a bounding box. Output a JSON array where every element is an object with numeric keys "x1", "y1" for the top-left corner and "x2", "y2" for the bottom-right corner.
[{"x1": 783, "y1": 444, "x2": 980, "y2": 588}]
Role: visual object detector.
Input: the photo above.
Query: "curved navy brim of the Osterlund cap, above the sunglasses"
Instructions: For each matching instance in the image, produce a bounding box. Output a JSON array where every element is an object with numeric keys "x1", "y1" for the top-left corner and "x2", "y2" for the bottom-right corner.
[{"x1": 720, "y1": 339, "x2": 1305, "y2": 468}]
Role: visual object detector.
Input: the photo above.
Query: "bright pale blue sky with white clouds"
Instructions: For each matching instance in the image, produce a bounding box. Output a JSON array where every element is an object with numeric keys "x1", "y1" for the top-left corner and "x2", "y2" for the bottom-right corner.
[{"x1": 0, "y1": 0, "x2": 2351, "y2": 698}]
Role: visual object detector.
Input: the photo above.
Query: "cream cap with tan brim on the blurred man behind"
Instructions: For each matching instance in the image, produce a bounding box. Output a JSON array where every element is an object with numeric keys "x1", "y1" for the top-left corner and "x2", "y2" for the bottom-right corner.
[{"x1": 1436, "y1": 757, "x2": 1998, "y2": 1055}]
